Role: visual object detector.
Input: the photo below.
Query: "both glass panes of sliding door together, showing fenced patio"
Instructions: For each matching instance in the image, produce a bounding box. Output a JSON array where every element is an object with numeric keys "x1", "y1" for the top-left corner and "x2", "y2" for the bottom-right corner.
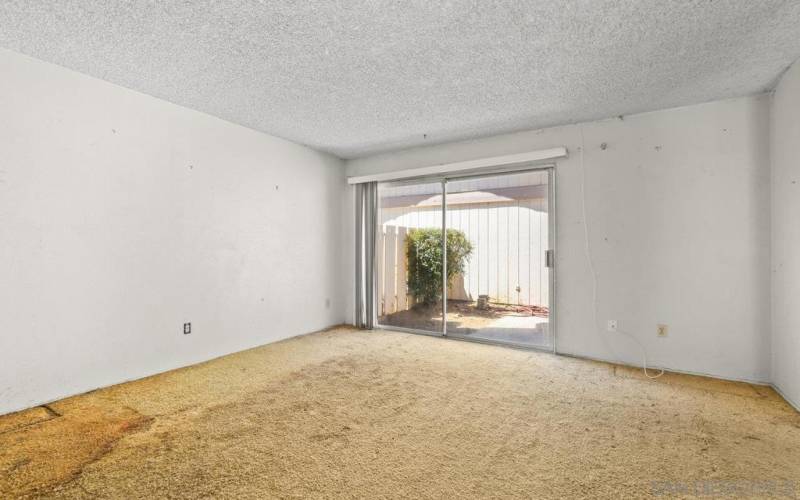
[{"x1": 376, "y1": 168, "x2": 555, "y2": 350}]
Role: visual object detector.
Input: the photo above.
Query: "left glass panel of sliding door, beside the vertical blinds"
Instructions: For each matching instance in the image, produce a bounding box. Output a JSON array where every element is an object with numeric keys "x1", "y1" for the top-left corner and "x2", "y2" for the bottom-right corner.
[{"x1": 375, "y1": 182, "x2": 444, "y2": 334}]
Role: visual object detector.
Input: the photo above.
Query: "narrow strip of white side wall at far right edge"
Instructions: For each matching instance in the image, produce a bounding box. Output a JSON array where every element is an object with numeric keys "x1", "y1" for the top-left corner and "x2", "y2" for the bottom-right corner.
[{"x1": 770, "y1": 62, "x2": 800, "y2": 408}]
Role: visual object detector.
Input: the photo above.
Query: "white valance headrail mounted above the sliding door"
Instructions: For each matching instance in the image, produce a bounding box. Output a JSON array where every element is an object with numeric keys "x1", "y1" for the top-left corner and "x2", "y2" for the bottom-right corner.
[{"x1": 347, "y1": 146, "x2": 567, "y2": 184}]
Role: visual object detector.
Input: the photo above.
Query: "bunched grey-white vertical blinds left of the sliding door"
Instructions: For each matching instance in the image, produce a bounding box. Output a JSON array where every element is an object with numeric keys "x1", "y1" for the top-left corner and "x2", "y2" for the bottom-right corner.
[{"x1": 355, "y1": 182, "x2": 378, "y2": 329}]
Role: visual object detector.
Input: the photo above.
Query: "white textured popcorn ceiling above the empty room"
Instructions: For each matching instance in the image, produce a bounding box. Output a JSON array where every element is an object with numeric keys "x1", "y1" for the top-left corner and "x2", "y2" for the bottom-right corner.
[{"x1": 0, "y1": 0, "x2": 800, "y2": 158}]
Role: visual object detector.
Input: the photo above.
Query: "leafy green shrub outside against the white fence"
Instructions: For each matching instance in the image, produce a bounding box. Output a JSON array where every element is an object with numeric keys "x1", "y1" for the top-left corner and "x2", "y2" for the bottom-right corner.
[{"x1": 406, "y1": 229, "x2": 472, "y2": 305}]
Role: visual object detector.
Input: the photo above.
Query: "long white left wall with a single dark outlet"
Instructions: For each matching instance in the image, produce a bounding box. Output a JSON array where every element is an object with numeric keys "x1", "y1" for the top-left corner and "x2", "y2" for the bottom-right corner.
[{"x1": 0, "y1": 51, "x2": 349, "y2": 414}]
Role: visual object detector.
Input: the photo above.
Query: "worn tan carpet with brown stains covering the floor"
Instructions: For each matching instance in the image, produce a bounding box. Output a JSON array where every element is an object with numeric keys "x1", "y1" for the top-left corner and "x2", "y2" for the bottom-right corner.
[{"x1": 0, "y1": 328, "x2": 800, "y2": 498}]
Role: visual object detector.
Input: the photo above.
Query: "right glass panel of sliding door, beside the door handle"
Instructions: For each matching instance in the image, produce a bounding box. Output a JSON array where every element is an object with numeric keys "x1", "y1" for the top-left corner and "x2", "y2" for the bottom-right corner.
[{"x1": 446, "y1": 169, "x2": 553, "y2": 350}]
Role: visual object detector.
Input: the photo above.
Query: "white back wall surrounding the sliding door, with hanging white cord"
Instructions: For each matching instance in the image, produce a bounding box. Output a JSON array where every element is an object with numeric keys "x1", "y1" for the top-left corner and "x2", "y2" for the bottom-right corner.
[{"x1": 347, "y1": 95, "x2": 770, "y2": 382}]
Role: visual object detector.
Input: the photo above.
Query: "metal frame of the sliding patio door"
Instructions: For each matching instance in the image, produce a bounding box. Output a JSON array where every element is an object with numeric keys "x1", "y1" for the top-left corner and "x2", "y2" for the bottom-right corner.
[{"x1": 375, "y1": 164, "x2": 558, "y2": 353}]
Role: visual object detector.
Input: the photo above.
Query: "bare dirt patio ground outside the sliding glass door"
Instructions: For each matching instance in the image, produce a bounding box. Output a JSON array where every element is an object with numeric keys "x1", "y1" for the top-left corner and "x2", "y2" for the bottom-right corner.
[{"x1": 378, "y1": 300, "x2": 548, "y2": 334}]
